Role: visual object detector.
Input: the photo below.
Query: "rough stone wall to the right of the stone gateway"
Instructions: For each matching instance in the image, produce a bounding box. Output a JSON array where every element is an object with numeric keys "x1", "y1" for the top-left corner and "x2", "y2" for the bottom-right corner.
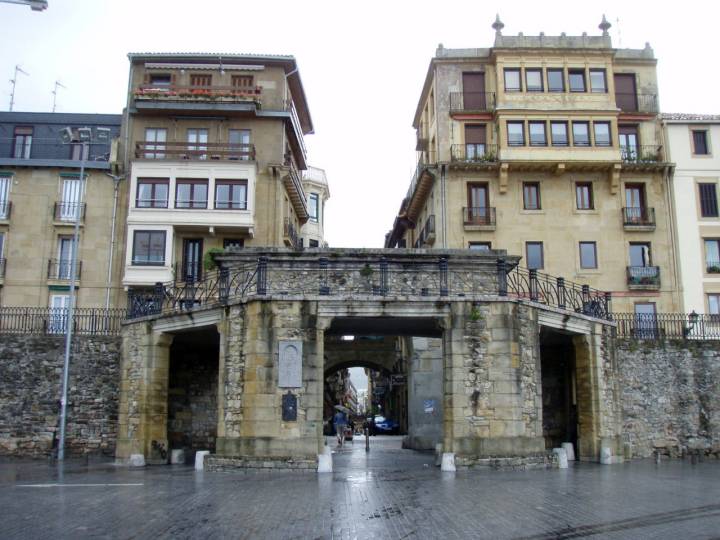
[{"x1": 615, "y1": 339, "x2": 720, "y2": 457}]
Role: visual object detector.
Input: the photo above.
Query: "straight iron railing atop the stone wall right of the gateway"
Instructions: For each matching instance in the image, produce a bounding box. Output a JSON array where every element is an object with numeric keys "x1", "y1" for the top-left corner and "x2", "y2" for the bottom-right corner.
[{"x1": 612, "y1": 312, "x2": 720, "y2": 340}]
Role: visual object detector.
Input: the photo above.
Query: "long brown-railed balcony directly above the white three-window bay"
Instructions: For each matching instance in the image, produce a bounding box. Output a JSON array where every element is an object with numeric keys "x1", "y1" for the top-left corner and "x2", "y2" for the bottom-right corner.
[{"x1": 135, "y1": 141, "x2": 255, "y2": 161}]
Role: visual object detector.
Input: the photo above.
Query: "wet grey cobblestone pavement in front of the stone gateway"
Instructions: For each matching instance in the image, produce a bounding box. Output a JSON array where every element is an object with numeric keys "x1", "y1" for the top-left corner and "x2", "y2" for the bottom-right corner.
[{"x1": 0, "y1": 437, "x2": 720, "y2": 539}]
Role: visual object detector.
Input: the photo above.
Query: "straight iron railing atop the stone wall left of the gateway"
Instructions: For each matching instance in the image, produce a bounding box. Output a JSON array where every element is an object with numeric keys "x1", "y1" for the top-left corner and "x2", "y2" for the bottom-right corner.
[{"x1": 0, "y1": 307, "x2": 127, "y2": 336}]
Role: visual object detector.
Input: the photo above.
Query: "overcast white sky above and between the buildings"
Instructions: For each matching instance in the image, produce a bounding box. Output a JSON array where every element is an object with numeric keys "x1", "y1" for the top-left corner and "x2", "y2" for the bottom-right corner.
[{"x1": 0, "y1": 0, "x2": 720, "y2": 247}]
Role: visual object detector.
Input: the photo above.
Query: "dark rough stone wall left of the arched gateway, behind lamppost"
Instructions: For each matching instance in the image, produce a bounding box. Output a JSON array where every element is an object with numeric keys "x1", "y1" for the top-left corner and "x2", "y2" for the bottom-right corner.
[{"x1": 0, "y1": 335, "x2": 121, "y2": 457}]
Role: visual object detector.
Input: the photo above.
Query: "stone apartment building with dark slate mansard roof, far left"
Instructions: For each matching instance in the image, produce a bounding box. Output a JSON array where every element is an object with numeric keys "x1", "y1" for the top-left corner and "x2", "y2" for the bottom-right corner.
[{"x1": 0, "y1": 112, "x2": 126, "y2": 308}]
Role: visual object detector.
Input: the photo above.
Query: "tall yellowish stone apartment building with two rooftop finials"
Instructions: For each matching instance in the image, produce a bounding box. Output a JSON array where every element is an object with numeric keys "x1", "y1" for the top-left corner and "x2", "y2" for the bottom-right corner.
[{"x1": 386, "y1": 18, "x2": 680, "y2": 313}]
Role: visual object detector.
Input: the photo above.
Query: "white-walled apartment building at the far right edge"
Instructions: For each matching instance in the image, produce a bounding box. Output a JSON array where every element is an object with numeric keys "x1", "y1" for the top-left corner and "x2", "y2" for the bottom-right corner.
[{"x1": 662, "y1": 114, "x2": 720, "y2": 315}]
